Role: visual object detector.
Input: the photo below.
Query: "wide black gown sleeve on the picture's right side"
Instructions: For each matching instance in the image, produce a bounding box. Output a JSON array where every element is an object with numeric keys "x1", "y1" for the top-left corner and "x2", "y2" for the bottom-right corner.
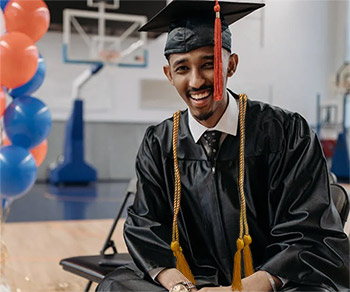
[{"x1": 260, "y1": 114, "x2": 349, "y2": 291}]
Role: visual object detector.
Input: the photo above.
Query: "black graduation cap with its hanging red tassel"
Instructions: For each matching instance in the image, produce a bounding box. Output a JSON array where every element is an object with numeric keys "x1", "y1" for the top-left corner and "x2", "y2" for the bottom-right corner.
[{"x1": 140, "y1": 0, "x2": 265, "y2": 100}]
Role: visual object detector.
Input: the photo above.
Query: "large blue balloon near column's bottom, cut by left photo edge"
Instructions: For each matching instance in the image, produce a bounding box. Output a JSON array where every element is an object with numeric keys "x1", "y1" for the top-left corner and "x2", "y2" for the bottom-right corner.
[{"x1": 0, "y1": 145, "x2": 37, "y2": 198}]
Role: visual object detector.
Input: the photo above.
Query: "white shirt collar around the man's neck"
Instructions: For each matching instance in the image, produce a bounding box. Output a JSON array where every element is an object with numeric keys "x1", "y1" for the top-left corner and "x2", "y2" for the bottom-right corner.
[{"x1": 188, "y1": 92, "x2": 239, "y2": 143}]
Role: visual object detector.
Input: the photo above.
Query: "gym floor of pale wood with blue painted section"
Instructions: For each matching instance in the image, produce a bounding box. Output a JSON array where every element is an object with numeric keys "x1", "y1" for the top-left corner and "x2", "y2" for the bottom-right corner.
[{"x1": 0, "y1": 181, "x2": 350, "y2": 292}]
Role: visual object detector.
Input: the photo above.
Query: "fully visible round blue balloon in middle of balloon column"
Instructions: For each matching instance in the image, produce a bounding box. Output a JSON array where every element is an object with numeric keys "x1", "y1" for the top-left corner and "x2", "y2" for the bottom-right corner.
[{"x1": 4, "y1": 95, "x2": 52, "y2": 149}]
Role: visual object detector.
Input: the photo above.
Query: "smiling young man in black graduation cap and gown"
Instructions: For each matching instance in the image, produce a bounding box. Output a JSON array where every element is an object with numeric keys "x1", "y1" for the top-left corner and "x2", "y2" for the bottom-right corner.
[{"x1": 97, "y1": 0, "x2": 349, "y2": 292}]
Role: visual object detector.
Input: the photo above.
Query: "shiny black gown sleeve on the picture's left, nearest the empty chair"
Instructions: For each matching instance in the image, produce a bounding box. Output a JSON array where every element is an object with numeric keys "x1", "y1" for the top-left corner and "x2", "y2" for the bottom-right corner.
[{"x1": 124, "y1": 127, "x2": 176, "y2": 274}]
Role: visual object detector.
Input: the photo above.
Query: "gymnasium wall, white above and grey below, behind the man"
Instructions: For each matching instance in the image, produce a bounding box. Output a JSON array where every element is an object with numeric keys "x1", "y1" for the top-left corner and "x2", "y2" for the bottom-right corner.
[{"x1": 35, "y1": 0, "x2": 348, "y2": 180}]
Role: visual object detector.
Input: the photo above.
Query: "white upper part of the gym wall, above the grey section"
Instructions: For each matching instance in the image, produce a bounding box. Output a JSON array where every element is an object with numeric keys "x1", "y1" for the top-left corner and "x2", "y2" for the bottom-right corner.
[{"x1": 35, "y1": 0, "x2": 348, "y2": 124}]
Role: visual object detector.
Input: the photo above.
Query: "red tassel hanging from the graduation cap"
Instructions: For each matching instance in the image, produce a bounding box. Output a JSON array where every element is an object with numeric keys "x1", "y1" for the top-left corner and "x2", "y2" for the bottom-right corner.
[{"x1": 214, "y1": 0, "x2": 223, "y2": 101}]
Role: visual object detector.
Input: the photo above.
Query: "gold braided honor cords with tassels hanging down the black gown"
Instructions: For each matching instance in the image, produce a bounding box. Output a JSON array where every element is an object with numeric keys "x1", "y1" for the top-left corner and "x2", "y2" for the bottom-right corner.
[{"x1": 171, "y1": 94, "x2": 254, "y2": 291}]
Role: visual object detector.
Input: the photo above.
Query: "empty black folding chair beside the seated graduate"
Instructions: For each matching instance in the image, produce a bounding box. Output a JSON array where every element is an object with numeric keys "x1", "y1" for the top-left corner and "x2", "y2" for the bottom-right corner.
[{"x1": 60, "y1": 178, "x2": 136, "y2": 291}]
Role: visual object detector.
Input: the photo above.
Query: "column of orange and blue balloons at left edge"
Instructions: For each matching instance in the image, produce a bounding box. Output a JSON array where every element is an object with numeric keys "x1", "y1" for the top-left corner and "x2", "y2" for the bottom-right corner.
[{"x1": 0, "y1": 0, "x2": 51, "y2": 210}]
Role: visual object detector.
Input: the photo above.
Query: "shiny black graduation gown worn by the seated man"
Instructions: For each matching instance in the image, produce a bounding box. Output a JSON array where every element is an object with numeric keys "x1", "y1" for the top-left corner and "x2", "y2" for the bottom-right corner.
[{"x1": 117, "y1": 100, "x2": 349, "y2": 290}]
